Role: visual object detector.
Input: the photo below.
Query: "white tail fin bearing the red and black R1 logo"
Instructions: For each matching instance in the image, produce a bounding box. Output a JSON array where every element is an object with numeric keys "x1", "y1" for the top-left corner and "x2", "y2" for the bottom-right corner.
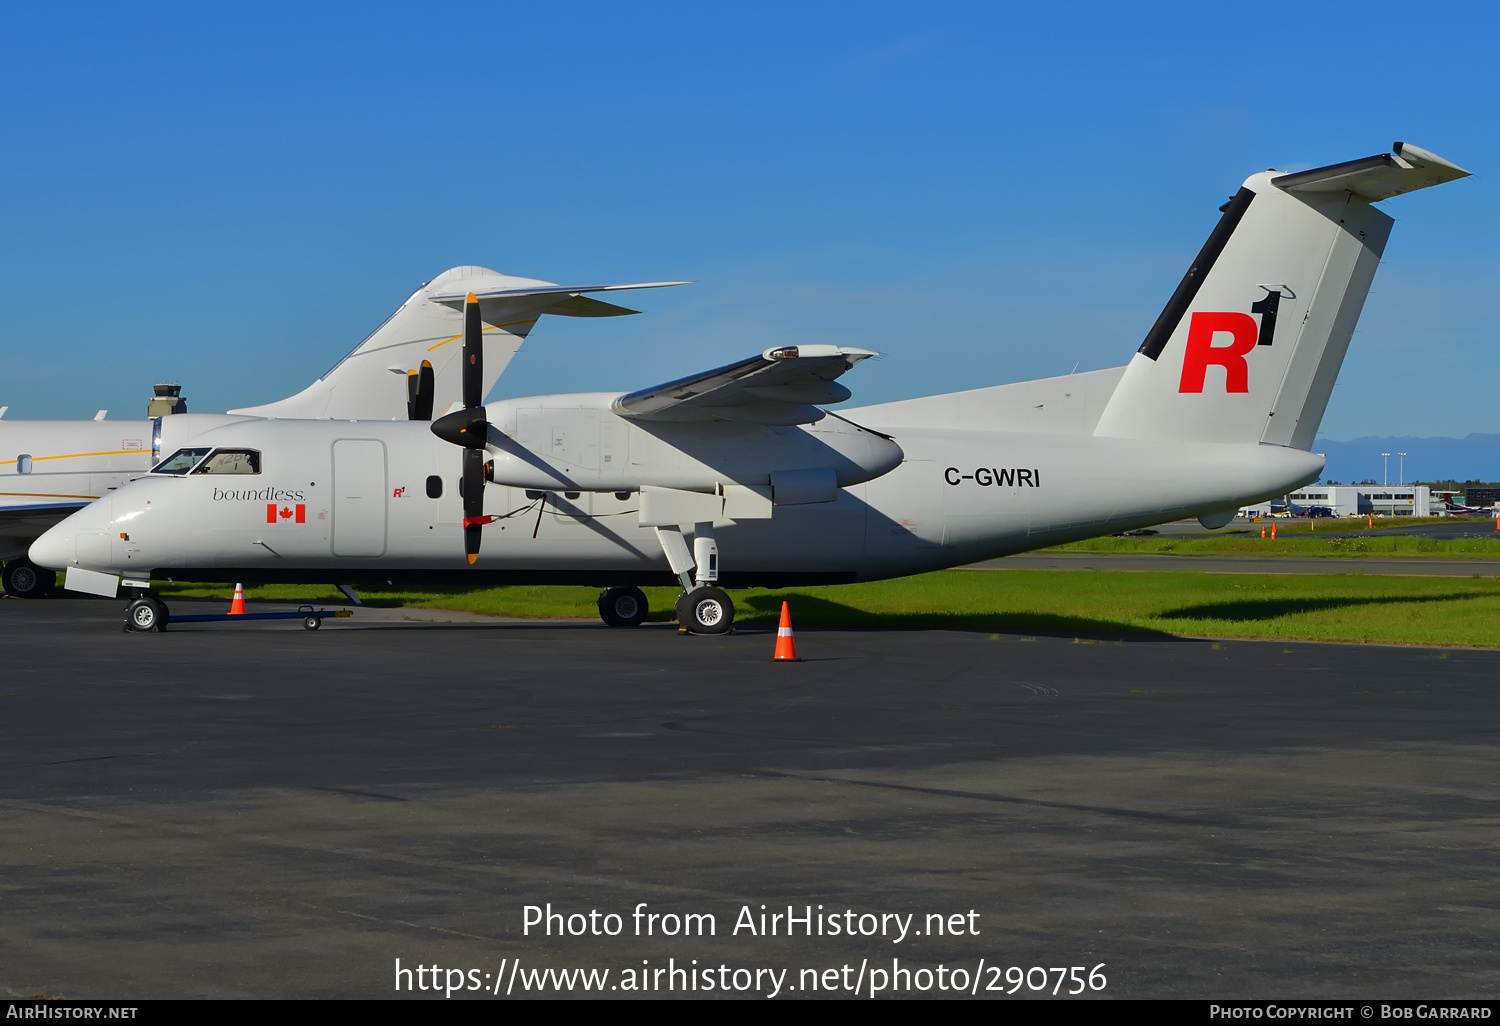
[{"x1": 1095, "y1": 143, "x2": 1469, "y2": 449}]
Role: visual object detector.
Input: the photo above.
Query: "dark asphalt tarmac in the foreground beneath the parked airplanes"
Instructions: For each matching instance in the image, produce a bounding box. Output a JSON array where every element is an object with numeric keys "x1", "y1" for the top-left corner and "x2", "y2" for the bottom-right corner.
[{"x1": 0, "y1": 600, "x2": 1500, "y2": 999}]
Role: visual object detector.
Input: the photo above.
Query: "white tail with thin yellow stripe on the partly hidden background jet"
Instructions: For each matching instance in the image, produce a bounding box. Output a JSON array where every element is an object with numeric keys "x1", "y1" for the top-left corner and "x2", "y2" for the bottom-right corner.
[{"x1": 230, "y1": 267, "x2": 686, "y2": 420}]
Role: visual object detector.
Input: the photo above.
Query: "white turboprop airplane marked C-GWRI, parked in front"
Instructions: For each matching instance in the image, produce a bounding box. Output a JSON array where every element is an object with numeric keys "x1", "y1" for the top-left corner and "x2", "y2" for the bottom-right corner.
[{"x1": 32, "y1": 143, "x2": 1469, "y2": 633}]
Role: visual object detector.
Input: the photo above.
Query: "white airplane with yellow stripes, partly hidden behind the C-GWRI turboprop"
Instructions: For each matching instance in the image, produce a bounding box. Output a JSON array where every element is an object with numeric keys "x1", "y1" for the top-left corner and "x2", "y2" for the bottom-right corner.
[{"x1": 0, "y1": 267, "x2": 683, "y2": 597}]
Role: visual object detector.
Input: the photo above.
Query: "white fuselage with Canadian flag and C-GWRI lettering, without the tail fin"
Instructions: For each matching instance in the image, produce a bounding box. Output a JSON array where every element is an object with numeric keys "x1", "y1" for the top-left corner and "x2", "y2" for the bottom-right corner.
[{"x1": 32, "y1": 396, "x2": 1323, "y2": 587}]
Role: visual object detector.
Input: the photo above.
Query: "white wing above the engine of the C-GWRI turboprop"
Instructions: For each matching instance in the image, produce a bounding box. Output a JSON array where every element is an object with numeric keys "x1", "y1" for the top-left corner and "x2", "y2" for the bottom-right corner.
[{"x1": 612, "y1": 345, "x2": 879, "y2": 425}]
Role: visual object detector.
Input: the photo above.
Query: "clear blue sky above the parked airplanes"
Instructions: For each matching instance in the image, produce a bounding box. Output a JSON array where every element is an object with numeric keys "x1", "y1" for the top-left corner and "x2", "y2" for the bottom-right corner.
[{"x1": 0, "y1": 3, "x2": 1500, "y2": 438}]
